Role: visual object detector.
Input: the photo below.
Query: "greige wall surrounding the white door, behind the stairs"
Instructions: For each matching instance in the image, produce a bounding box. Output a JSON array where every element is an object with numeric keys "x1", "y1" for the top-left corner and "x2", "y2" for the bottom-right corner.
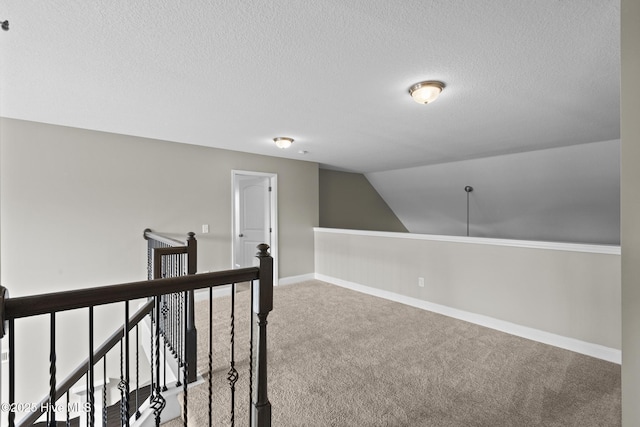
[{"x1": 0, "y1": 119, "x2": 318, "y2": 296}]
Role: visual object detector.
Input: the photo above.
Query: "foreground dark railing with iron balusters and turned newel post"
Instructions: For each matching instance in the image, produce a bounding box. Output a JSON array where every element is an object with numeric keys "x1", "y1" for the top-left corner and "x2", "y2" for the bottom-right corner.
[{"x1": 0, "y1": 244, "x2": 273, "y2": 427}]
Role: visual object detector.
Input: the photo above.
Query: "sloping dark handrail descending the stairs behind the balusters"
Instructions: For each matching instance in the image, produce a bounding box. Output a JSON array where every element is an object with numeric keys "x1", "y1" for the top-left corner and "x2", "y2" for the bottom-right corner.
[{"x1": 16, "y1": 300, "x2": 154, "y2": 426}]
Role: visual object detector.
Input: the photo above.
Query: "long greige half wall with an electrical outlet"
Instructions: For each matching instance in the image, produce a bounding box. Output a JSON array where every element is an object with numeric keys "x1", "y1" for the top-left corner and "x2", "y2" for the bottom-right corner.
[{"x1": 315, "y1": 228, "x2": 621, "y2": 363}]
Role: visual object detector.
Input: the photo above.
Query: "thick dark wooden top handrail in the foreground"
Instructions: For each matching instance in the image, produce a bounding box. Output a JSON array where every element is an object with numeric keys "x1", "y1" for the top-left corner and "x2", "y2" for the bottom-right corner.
[{"x1": 0, "y1": 267, "x2": 260, "y2": 320}]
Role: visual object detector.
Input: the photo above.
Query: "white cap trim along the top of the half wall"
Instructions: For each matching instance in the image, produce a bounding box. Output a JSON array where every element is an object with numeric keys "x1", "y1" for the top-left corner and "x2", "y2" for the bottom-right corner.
[{"x1": 313, "y1": 227, "x2": 621, "y2": 255}]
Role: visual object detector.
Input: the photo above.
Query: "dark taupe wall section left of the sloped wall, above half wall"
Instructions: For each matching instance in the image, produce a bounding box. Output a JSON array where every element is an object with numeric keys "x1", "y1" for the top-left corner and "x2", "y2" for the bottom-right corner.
[{"x1": 320, "y1": 169, "x2": 407, "y2": 232}]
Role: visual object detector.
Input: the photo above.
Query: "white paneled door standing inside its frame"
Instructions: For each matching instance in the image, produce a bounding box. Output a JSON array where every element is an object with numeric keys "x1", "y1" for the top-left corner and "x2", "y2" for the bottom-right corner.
[{"x1": 233, "y1": 172, "x2": 273, "y2": 268}]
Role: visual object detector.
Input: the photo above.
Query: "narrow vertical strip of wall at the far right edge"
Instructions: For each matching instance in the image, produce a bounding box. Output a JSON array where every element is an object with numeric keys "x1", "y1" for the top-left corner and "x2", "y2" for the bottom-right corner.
[{"x1": 620, "y1": 0, "x2": 640, "y2": 427}]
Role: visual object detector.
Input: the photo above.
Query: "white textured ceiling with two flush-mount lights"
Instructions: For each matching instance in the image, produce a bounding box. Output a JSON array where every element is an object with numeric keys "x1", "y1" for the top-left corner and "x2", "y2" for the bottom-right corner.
[{"x1": 0, "y1": 0, "x2": 620, "y2": 172}]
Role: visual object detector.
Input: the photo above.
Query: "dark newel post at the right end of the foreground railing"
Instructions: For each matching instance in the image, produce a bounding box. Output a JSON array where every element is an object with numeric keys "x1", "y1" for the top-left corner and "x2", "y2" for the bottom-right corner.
[{"x1": 251, "y1": 243, "x2": 273, "y2": 427}]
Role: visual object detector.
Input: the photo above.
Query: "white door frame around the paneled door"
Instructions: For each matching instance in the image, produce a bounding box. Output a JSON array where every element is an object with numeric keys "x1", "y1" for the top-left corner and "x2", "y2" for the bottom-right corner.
[{"x1": 231, "y1": 169, "x2": 278, "y2": 285}]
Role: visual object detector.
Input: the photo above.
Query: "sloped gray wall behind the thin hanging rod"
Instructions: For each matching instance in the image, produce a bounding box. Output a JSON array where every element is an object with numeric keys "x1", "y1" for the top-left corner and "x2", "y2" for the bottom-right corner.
[{"x1": 366, "y1": 140, "x2": 620, "y2": 245}]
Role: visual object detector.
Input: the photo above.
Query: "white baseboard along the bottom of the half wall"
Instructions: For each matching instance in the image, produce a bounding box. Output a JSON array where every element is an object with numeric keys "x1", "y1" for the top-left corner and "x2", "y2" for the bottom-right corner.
[{"x1": 315, "y1": 273, "x2": 622, "y2": 364}]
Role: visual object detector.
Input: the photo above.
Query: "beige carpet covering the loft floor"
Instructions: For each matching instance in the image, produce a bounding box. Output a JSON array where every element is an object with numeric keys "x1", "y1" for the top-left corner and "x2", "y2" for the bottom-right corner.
[{"x1": 162, "y1": 281, "x2": 621, "y2": 427}]
